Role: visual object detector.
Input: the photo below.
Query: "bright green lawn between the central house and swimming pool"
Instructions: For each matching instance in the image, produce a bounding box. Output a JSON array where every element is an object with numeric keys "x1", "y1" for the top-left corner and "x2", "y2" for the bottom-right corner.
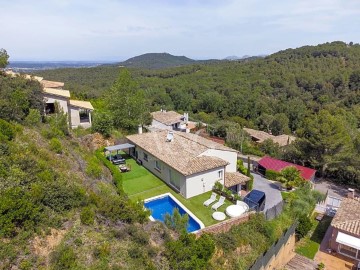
[{"x1": 122, "y1": 155, "x2": 232, "y2": 226}]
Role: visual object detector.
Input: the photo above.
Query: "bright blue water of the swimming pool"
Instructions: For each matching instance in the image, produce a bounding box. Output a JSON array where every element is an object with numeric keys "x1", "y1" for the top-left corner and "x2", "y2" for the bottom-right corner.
[{"x1": 144, "y1": 195, "x2": 201, "y2": 232}]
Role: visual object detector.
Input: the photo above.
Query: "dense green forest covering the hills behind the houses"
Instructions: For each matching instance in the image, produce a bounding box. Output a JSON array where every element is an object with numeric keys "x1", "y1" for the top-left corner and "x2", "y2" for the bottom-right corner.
[{"x1": 38, "y1": 42, "x2": 360, "y2": 186}]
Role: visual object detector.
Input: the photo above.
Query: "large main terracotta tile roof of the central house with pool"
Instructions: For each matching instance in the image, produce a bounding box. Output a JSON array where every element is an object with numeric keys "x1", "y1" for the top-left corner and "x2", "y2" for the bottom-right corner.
[{"x1": 127, "y1": 130, "x2": 231, "y2": 176}]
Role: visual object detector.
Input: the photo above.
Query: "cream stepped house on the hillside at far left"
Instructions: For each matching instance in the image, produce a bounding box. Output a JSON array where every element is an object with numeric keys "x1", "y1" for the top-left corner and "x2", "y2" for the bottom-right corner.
[{"x1": 5, "y1": 70, "x2": 94, "y2": 128}]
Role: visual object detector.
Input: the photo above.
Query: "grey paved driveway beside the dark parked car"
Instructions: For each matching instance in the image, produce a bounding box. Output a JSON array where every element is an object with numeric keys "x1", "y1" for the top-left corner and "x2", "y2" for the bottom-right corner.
[{"x1": 252, "y1": 173, "x2": 282, "y2": 211}]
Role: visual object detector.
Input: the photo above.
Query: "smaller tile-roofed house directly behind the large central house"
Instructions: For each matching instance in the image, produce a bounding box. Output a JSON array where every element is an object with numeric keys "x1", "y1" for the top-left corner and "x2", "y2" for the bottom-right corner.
[{"x1": 149, "y1": 110, "x2": 195, "y2": 131}]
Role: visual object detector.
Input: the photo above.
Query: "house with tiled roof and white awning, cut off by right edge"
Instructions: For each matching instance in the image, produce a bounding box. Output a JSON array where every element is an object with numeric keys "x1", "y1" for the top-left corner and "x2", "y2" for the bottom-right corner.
[{"x1": 329, "y1": 198, "x2": 360, "y2": 260}]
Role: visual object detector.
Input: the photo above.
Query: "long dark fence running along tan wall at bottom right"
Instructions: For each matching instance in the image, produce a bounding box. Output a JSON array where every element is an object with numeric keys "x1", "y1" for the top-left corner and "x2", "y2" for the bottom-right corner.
[{"x1": 250, "y1": 223, "x2": 297, "y2": 270}]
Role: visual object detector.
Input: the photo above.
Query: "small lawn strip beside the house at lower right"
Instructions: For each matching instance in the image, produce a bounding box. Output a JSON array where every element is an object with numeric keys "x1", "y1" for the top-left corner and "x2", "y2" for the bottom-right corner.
[{"x1": 295, "y1": 214, "x2": 332, "y2": 259}]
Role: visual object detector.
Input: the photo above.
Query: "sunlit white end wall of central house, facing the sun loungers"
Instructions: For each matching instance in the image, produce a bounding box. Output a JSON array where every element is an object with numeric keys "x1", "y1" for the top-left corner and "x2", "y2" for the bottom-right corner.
[{"x1": 185, "y1": 167, "x2": 225, "y2": 198}]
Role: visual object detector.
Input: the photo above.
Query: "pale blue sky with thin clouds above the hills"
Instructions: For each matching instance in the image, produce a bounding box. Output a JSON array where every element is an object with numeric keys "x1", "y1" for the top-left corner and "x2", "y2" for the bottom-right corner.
[{"x1": 0, "y1": 0, "x2": 360, "y2": 61}]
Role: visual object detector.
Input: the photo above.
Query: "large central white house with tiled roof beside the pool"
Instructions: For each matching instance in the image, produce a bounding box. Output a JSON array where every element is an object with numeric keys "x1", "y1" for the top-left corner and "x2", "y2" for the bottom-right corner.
[{"x1": 127, "y1": 130, "x2": 249, "y2": 198}]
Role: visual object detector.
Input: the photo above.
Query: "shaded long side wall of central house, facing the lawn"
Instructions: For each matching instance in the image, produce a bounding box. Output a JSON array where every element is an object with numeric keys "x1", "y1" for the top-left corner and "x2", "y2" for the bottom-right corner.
[{"x1": 135, "y1": 146, "x2": 186, "y2": 197}]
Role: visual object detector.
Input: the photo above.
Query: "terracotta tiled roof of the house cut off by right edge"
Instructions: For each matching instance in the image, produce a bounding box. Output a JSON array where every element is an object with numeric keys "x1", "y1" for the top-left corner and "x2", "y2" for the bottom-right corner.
[{"x1": 331, "y1": 198, "x2": 360, "y2": 236}]
